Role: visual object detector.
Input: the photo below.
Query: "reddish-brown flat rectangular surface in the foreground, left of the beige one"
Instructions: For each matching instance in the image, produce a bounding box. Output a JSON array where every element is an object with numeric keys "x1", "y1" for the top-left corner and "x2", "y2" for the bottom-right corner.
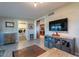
[{"x1": 12, "y1": 45, "x2": 46, "y2": 57}]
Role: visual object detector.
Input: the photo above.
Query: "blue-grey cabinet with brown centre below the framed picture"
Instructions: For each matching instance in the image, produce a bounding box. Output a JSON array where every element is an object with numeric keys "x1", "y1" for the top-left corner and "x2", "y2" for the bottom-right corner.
[{"x1": 0, "y1": 33, "x2": 17, "y2": 45}]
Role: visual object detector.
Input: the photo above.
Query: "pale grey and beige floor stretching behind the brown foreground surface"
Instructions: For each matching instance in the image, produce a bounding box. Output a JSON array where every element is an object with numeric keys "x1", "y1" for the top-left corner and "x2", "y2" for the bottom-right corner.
[{"x1": 0, "y1": 39, "x2": 48, "y2": 57}]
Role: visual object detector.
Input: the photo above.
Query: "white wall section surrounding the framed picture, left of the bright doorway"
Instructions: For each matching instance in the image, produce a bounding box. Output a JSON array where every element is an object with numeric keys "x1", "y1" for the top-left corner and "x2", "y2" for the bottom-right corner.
[{"x1": 2, "y1": 19, "x2": 18, "y2": 33}]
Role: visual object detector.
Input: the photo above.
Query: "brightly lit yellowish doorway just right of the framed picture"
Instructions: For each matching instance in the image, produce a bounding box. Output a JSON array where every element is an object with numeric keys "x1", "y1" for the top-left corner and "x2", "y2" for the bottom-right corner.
[{"x1": 18, "y1": 20, "x2": 27, "y2": 42}]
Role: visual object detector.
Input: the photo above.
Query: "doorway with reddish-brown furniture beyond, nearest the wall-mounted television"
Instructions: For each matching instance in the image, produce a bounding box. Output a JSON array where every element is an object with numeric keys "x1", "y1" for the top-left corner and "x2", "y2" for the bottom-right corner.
[{"x1": 36, "y1": 20, "x2": 45, "y2": 39}]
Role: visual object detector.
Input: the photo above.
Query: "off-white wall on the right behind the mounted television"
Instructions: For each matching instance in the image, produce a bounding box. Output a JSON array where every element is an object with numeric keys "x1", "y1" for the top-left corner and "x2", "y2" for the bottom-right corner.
[{"x1": 34, "y1": 3, "x2": 79, "y2": 54}]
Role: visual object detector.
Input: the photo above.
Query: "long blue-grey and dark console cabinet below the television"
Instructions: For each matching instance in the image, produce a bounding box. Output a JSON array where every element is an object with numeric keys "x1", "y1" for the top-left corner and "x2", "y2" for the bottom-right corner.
[{"x1": 44, "y1": 36, "x2": 75, "y2": 54}]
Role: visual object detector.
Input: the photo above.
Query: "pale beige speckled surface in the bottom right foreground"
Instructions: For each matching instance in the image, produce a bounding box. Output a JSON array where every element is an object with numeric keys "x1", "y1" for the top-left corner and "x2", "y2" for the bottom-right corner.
[{"x1": 38, "y1": 48, "x2": 76, "y2": 57}]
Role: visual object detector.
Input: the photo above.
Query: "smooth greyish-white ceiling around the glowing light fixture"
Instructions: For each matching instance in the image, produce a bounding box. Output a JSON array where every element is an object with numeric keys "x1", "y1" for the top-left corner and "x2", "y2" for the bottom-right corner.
[{"x1": 0, "y1": 2, "x2": 67, "y2": 19}]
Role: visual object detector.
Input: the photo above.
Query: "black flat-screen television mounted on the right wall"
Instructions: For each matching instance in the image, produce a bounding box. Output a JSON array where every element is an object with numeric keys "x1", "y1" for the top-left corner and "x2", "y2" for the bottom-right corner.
[{"x1": 49, "y1": 18, "x2": 68, "y2": 31}]
